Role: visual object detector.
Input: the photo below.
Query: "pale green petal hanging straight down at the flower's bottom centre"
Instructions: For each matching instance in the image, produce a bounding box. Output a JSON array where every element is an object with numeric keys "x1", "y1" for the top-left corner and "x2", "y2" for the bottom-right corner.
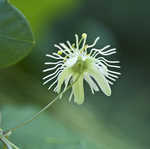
[{"x1": 72, "y1": 75, "x2": 84, "y2": 104}]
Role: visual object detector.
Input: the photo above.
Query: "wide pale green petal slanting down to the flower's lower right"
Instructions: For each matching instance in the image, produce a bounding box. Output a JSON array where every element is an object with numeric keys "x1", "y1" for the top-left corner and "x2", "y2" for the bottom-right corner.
[{"x1": 87, "y1": 64, "x2": 111, "y2": 96}]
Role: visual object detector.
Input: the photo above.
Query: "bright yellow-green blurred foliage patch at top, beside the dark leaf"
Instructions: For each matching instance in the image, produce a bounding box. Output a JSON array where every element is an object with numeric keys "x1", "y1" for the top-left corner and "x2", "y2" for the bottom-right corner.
[{"x1": 11, "y1": 0, "x2": 79, "y2": 36}]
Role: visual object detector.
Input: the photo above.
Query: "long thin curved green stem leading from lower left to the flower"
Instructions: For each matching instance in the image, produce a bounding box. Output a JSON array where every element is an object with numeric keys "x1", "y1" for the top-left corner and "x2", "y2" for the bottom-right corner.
[{"x1": 6, "y1": 77, "x2": 79, "y2": 133}]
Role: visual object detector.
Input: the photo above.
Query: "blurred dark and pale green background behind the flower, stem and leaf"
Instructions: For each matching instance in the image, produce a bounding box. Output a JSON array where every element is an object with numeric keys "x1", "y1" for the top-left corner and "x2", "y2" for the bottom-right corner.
[{"x1": 0, "y1": 0, "x2": 150, "y2": 149}]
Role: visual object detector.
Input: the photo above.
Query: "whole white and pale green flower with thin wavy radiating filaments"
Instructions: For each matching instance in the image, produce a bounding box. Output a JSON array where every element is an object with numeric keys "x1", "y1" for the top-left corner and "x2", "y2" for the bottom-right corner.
[{"x1": 43, "y1": 33, "x2": 120, "y2": 104}]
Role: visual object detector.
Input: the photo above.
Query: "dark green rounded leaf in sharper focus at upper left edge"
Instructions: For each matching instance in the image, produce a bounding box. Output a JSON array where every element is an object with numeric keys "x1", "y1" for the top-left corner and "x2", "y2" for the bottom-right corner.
[{"x1": 0, "y1": 0, "x2": 35, "y2": 68}]
